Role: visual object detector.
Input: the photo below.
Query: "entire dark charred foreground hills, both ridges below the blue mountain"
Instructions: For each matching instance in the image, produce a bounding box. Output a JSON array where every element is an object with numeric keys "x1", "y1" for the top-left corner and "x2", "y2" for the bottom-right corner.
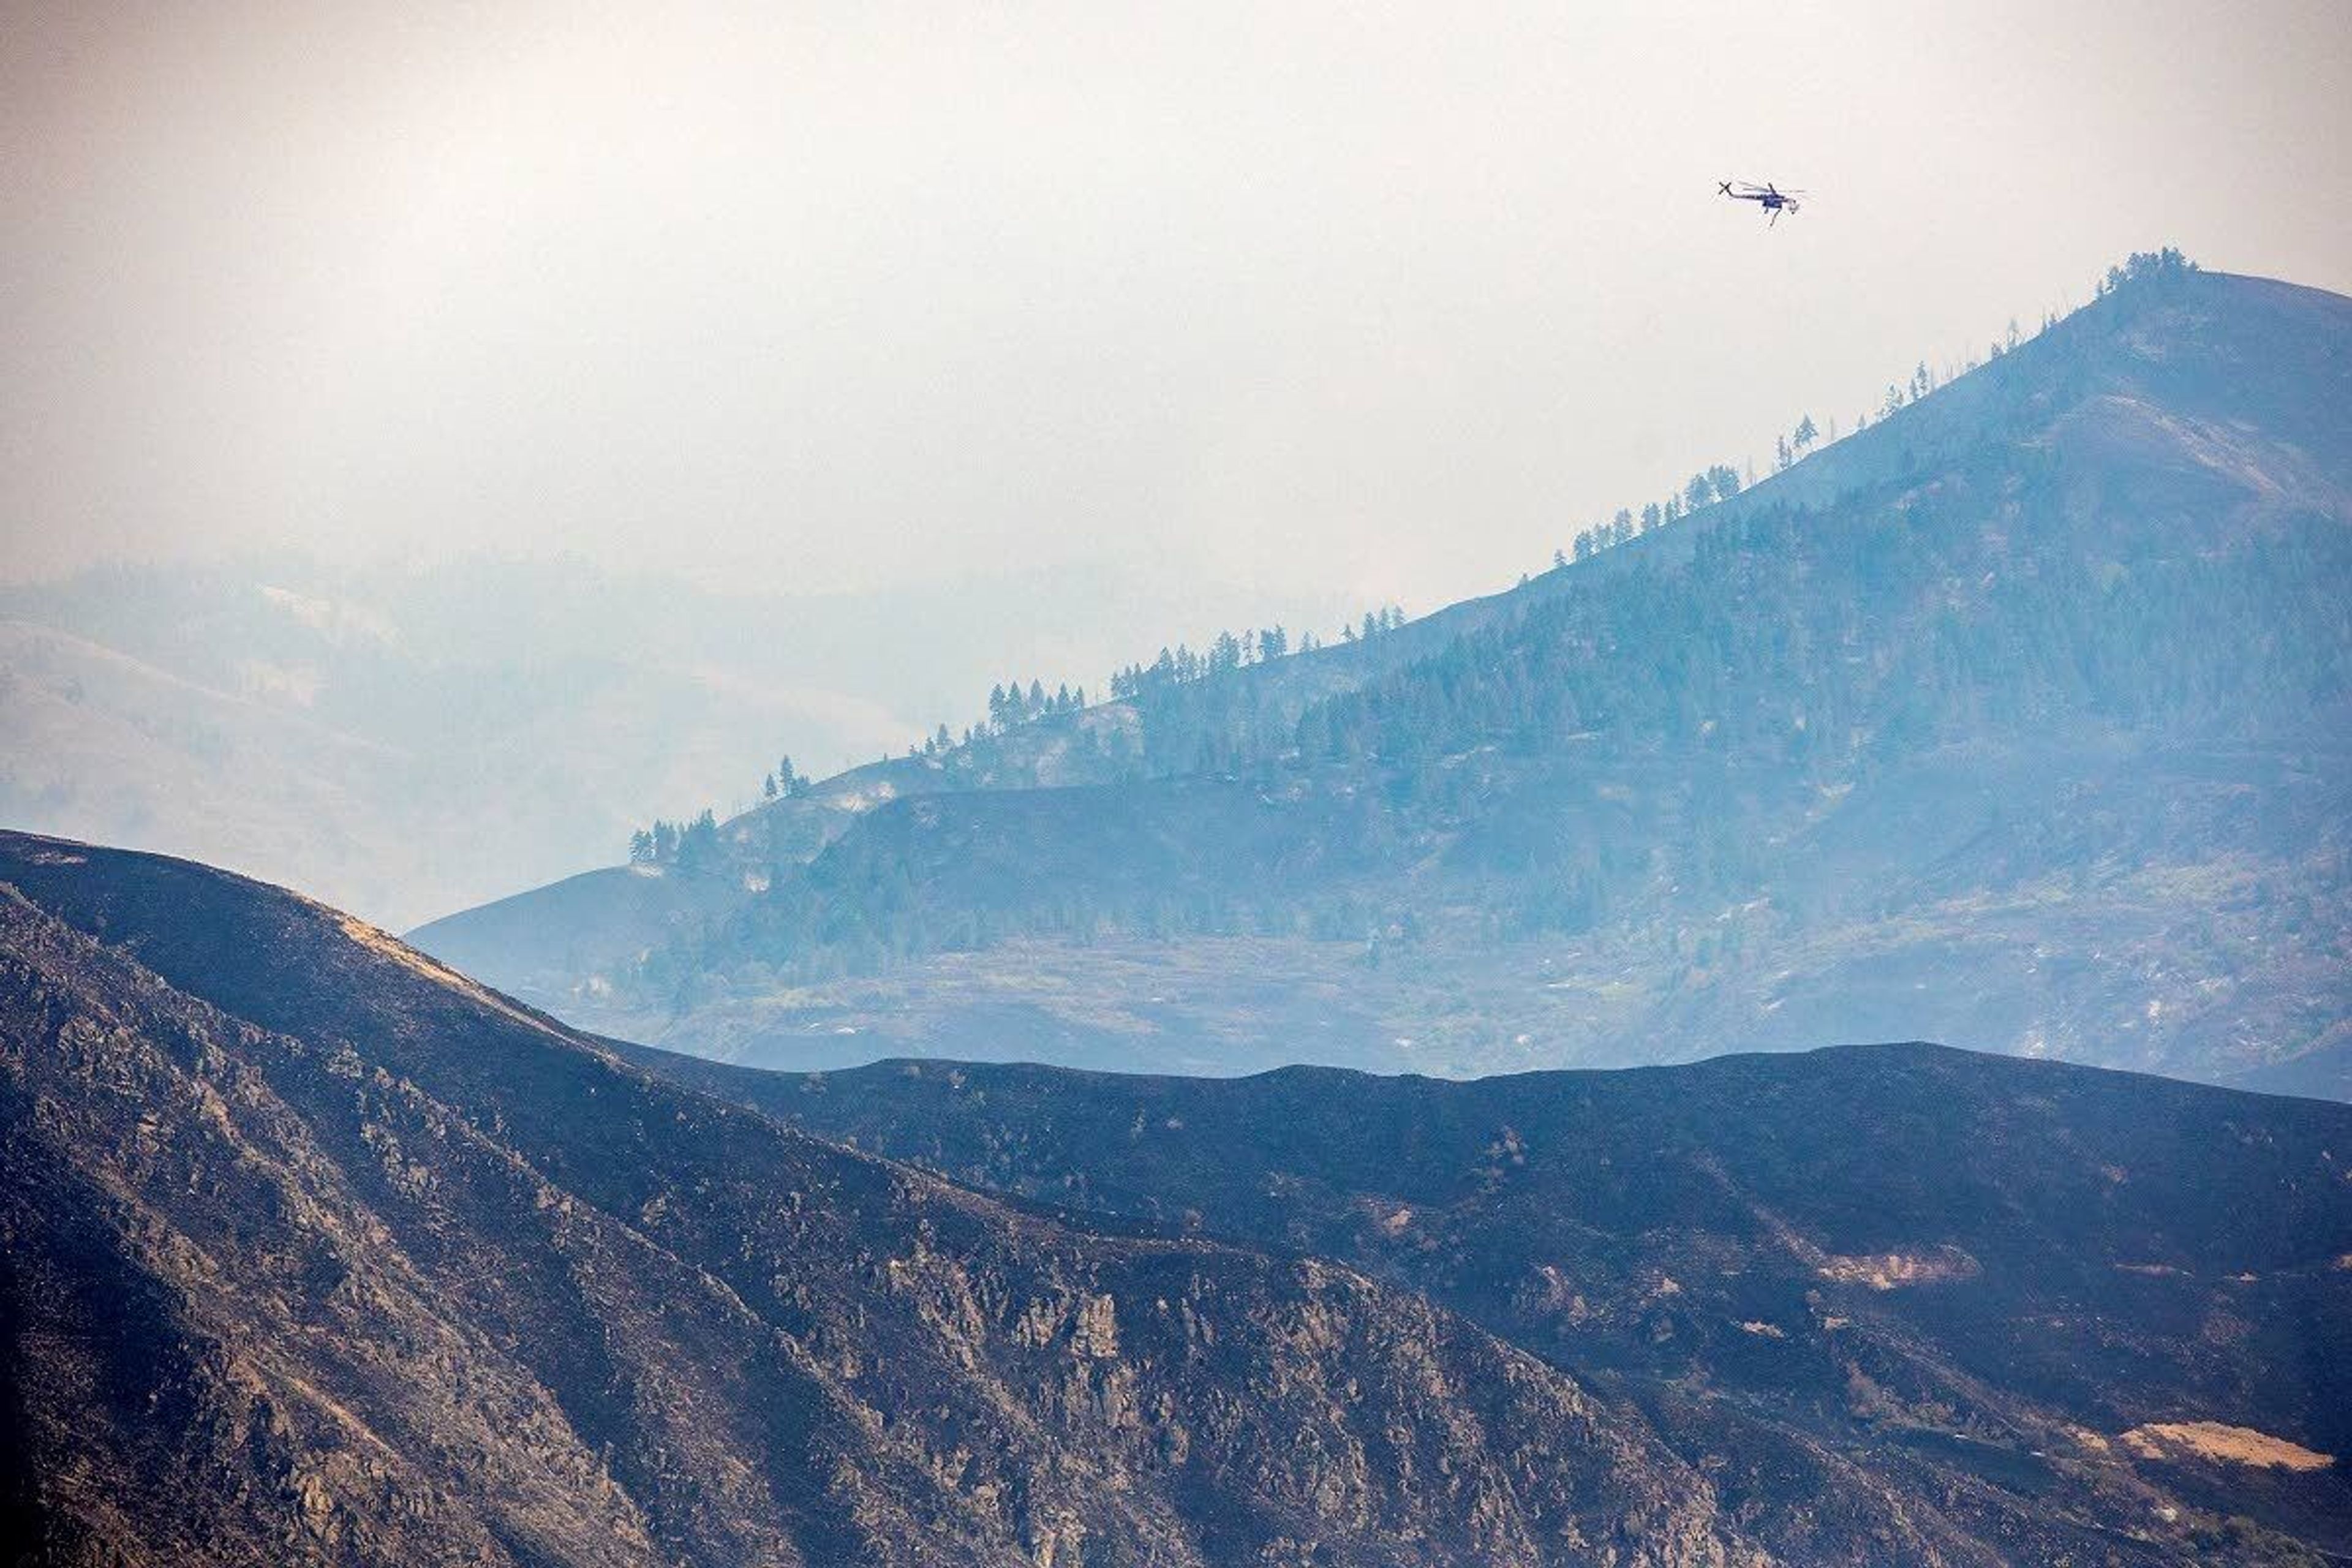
[{"x1": 0, "y1": 835, "x2": 2352, "y2": 1568}]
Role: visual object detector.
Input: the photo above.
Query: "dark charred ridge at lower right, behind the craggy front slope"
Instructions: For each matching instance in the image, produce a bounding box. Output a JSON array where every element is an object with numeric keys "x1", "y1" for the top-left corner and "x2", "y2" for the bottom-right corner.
[{"x1": 639, "y1": 1046, "x2": 2352, "y2": 1551}]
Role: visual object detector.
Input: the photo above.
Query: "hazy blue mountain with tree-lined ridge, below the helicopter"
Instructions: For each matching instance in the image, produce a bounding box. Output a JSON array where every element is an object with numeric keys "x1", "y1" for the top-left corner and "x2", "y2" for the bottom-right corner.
[{"x1": 414, "y1": 258, "x2": 2352, "y2": 1096}]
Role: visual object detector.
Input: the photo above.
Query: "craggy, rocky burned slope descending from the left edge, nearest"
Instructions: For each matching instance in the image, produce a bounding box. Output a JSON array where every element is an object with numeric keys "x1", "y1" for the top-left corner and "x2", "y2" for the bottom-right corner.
[{"x1": 0, "y1": 837, "x2": 1759, "y2": 1563}]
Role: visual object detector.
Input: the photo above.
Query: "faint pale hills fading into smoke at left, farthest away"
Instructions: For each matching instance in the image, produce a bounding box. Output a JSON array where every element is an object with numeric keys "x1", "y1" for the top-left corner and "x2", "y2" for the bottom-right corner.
[{"x1": 0, "y1": 552, "x2": 1364, "y2": 924}]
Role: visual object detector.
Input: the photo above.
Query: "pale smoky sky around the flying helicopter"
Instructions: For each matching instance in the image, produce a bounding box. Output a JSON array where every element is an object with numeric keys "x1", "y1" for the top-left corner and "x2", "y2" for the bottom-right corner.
[{"x1": 0, "y1": 0, "x2": 2352, "y2": 630}]
